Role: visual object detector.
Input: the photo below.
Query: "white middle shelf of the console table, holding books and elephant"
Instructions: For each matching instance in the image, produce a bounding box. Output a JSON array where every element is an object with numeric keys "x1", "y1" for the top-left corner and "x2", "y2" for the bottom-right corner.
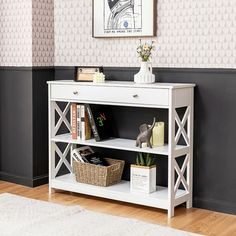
[{"x1": 51, "y1": 133, "x2": 189, "y2": 156}]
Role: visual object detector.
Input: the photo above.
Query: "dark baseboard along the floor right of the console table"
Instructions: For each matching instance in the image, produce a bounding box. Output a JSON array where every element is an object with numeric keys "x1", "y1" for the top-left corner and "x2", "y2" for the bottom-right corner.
[{"x1": 193, "y1": 197, "x2": 236, "y2": 215}]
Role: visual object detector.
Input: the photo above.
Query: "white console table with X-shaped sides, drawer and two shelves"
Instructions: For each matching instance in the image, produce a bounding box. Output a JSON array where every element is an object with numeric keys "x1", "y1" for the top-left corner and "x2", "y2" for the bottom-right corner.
[{"x1": 48, "y1": 81, "x2": 195, "y2": 217}]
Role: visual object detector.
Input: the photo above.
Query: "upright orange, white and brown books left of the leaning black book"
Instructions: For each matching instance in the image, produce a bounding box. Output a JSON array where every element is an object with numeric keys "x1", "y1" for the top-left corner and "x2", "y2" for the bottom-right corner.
[{"x1": 71, "y1": 103, "x2": 91, "y2": 140}]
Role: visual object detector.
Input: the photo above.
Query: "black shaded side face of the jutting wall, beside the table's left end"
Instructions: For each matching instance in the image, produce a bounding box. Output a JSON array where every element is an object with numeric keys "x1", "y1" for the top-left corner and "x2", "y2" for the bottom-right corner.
[{"x1": 33, "y1": 68, "x2": 54, "y2": 185}]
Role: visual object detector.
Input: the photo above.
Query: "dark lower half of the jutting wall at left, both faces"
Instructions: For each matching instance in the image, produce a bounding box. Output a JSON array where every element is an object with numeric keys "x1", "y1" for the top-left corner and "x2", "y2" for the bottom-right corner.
[{"x1": 0, "y1": 67, "x2": 54, "y2": 187}]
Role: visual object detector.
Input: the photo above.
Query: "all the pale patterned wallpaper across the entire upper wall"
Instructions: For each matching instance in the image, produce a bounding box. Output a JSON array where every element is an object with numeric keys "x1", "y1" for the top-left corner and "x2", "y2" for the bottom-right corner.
[{"x1": 0, "y1": 0, "x2": 236, "y2": 68}]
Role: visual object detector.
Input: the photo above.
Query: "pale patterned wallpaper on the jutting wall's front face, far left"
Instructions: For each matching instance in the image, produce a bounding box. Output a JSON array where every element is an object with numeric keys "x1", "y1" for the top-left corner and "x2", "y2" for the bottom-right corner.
[{"x1": 0, "y1": 0, "x2": 32, "y2": 66}]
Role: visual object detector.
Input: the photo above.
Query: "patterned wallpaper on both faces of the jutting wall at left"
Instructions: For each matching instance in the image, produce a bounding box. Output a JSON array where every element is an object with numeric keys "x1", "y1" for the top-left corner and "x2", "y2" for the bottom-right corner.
[{"x1": 0, "y1": 0, "x2": 54, "y2": 66}]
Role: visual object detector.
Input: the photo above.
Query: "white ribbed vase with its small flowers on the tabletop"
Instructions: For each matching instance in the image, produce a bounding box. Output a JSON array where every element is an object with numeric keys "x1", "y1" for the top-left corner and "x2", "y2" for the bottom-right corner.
[{"x1": 134, "y1": 39, "x2": 155, "y2": 84}]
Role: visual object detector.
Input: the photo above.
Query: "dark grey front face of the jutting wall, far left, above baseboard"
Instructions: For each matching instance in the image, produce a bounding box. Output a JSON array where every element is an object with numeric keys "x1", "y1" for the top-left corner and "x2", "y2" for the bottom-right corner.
[{"x1": 0, "y1": 69, "x2": 33, "y2": 182}]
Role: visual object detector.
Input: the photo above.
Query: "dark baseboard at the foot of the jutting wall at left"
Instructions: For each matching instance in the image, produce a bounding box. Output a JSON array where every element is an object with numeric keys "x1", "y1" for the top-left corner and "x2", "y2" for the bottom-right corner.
[{"x1": 0, "y1": 172, "x2": 48, "y2": 188}]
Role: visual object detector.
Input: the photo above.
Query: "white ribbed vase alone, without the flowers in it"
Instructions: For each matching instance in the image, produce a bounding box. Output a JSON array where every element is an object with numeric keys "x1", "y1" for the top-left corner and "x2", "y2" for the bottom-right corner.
[{"x1": 134, "y1": 61, "x2": 155, "y2": 84}]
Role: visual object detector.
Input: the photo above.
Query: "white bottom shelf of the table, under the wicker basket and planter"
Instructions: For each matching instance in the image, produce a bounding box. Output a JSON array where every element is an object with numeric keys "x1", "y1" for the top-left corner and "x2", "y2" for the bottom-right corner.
[{"x1": 51, "y1": 174, "x2": 188, "y2": 209}]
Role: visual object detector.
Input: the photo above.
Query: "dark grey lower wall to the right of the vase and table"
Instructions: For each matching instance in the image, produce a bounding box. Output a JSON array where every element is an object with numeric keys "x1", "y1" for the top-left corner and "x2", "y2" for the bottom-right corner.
[{"x1": 157, "y1": 70, "x2": 236, "y2": 213}]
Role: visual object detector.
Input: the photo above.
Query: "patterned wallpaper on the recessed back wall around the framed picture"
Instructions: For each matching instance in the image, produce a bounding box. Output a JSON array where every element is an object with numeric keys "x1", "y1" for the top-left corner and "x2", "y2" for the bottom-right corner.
[{"x1": 54, "y1": 0, "x2": 236, "y2": 68}]
